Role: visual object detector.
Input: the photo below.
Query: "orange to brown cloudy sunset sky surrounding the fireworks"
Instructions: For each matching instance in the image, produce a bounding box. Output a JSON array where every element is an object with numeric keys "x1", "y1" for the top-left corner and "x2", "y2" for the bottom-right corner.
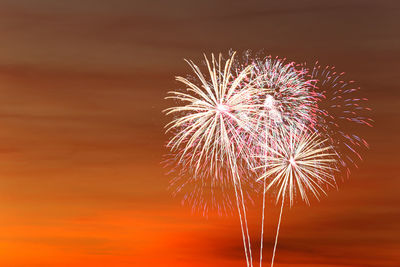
[{"x1": 0, "y1": 0, "x2": 400, "y2": 267}]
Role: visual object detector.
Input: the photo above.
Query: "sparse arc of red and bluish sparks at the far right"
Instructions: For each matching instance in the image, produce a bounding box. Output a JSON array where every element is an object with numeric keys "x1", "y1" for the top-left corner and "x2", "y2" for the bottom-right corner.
[{"x1": 310, "y1": 64, "x2": 373, "y2": 177}]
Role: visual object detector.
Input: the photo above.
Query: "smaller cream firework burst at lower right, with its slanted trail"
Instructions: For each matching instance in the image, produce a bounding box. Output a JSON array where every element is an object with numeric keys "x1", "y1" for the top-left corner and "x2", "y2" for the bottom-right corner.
[{"x1": 255, "y1": 127, "x2": 336, "y2": 267}]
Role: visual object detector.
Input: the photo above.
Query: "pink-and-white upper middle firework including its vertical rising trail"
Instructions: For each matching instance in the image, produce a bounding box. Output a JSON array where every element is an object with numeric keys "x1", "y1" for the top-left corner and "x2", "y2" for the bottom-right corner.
[{"x1": 242, "y1": 56, "x2": 316, "y2": 266}]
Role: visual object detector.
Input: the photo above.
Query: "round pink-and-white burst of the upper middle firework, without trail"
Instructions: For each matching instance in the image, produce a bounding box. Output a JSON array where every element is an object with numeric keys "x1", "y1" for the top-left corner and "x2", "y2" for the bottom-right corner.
[{"x1": 252, "y1": 57, "x2": 317, "y2": 130}]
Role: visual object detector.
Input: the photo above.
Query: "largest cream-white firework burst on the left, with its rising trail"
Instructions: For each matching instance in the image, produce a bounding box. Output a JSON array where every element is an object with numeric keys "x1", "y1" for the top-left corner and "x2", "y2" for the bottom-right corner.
[{"x1": 166, "y1": 54, "x2": 257, "y2": 266}]
